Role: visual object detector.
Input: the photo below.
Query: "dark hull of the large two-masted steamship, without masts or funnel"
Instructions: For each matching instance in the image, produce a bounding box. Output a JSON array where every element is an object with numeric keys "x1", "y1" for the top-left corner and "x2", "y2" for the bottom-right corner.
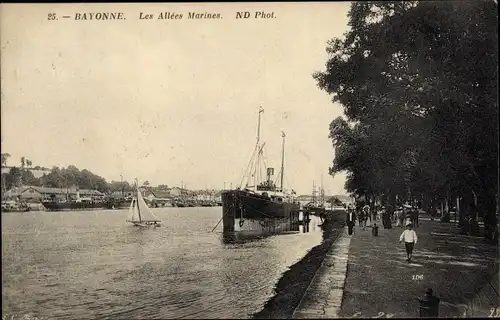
[{"x1": 222, "y1": 190, "x2": 300, "y2": 234}]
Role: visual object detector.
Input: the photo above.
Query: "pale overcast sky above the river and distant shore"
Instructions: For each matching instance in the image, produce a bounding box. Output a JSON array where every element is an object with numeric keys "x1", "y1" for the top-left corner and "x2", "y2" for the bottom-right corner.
[{"x1": 0, "y1": 2, "x2": 349, "y2": 194}]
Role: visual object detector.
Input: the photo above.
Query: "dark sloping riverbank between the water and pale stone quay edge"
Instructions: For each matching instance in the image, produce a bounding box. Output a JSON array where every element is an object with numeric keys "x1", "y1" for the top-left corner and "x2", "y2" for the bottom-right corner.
[{"x1": 253, "y1": 213, "x2": 345, "y2": 319}]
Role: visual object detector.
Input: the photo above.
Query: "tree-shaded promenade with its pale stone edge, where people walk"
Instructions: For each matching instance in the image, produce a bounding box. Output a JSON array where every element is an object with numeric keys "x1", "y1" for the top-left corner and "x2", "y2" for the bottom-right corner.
[{"x1": 293, "y1": 215, "x2": 500, "y2": 318}]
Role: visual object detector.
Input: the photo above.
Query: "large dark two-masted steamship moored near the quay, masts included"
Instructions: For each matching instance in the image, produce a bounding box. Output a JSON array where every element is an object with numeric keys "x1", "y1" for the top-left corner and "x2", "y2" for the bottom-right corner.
[{"x1": 221, "y1": 107, "x2": 300, "y2": 233}]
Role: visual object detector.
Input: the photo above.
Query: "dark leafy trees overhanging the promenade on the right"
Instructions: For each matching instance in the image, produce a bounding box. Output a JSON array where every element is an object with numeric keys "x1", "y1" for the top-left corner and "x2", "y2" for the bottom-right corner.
[{"x1": 314, "y1": 1, "x2": 498, "y2": 239}]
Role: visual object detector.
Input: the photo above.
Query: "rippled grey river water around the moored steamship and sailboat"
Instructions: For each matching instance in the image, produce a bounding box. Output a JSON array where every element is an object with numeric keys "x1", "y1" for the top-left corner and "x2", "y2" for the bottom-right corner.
[{"x1": 2, "y1": 207, "x2": 322, "y2": 319}]
